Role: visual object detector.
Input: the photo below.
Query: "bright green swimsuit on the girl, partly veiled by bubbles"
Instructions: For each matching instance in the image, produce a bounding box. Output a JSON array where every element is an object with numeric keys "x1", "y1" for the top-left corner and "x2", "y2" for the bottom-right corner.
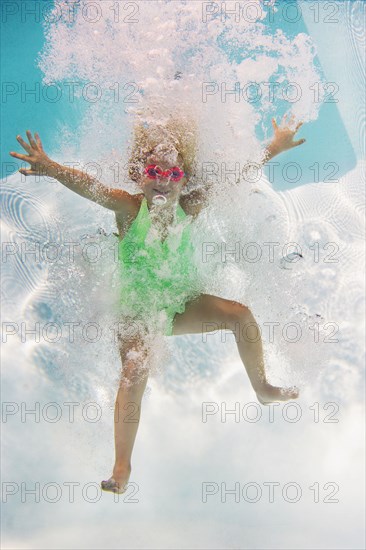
[{"x1": 118, "y1": 198, "x2": 200, "y2": 336}]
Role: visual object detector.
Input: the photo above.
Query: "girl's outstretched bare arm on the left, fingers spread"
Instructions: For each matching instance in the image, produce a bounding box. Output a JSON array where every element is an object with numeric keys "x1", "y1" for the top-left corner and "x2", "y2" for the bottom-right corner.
[{"x1": 10, "y1": 130, "x2": 135, "y2": 212}]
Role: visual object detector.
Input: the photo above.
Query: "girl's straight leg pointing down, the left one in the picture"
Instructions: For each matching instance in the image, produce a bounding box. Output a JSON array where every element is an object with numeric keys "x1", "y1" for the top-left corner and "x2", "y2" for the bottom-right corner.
[{"x1": 102, "y1": 326, "x2": 149, "y2": 493}]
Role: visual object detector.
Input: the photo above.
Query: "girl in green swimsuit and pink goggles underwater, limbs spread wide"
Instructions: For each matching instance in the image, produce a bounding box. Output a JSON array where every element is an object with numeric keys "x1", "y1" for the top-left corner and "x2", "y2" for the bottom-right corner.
[{"x1": 10, "y1": 116, "x2": 305, "y2": 493}]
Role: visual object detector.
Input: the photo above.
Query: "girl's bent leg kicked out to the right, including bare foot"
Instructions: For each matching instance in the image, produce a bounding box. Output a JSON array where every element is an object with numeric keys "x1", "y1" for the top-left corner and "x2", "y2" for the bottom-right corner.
[{"x1": 173, "y1": 294, "x2": 299, "y2": 404}]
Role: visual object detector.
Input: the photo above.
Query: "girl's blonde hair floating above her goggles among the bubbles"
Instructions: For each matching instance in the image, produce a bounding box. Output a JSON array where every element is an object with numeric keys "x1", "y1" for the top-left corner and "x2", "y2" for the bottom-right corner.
[{"x1": 128, "y1": 115, "x2": 197, "y2": 182}]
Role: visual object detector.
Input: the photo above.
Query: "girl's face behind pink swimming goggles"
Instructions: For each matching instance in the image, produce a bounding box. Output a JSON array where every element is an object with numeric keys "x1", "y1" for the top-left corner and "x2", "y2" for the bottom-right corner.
[{"x1": 140, "y1": 155, "x2": 188, "y2": 206}]
